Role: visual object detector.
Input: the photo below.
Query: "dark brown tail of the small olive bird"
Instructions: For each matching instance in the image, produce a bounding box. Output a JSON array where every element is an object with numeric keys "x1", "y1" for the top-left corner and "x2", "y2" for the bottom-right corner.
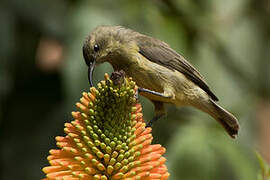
[{"x1": 210, "y1": 99, "x2": 239, "y2": 138}]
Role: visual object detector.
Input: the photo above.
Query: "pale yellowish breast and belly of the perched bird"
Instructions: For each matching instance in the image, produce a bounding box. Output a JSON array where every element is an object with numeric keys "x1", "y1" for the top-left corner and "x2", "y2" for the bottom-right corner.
[{"x1": 109, "y1": 52, "x2": 198, "y2": 105}]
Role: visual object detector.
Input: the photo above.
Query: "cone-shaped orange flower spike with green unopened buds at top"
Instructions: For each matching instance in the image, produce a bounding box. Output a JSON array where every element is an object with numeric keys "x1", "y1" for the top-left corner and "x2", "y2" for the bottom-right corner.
[{"x1": 43, "y1": 74, "x2": 169, "y2": 180}]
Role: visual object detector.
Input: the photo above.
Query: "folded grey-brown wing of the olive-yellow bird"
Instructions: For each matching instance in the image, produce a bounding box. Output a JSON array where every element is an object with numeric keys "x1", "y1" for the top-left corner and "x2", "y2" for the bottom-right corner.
[{"x1": 135, "y1": 35, "x2": 218, "y2": 101}]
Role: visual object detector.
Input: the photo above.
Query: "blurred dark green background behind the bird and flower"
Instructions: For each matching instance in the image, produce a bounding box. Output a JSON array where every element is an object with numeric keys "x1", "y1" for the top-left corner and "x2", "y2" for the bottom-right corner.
[{"x1": 0, "y1": 0, "x2": 270, "y2": 180}]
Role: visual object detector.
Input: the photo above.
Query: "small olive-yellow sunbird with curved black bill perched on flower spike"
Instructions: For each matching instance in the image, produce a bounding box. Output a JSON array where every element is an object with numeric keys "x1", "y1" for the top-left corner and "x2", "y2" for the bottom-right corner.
[{"x1": 82, "y1": 26, "x2": 239, "y2": 138}]
